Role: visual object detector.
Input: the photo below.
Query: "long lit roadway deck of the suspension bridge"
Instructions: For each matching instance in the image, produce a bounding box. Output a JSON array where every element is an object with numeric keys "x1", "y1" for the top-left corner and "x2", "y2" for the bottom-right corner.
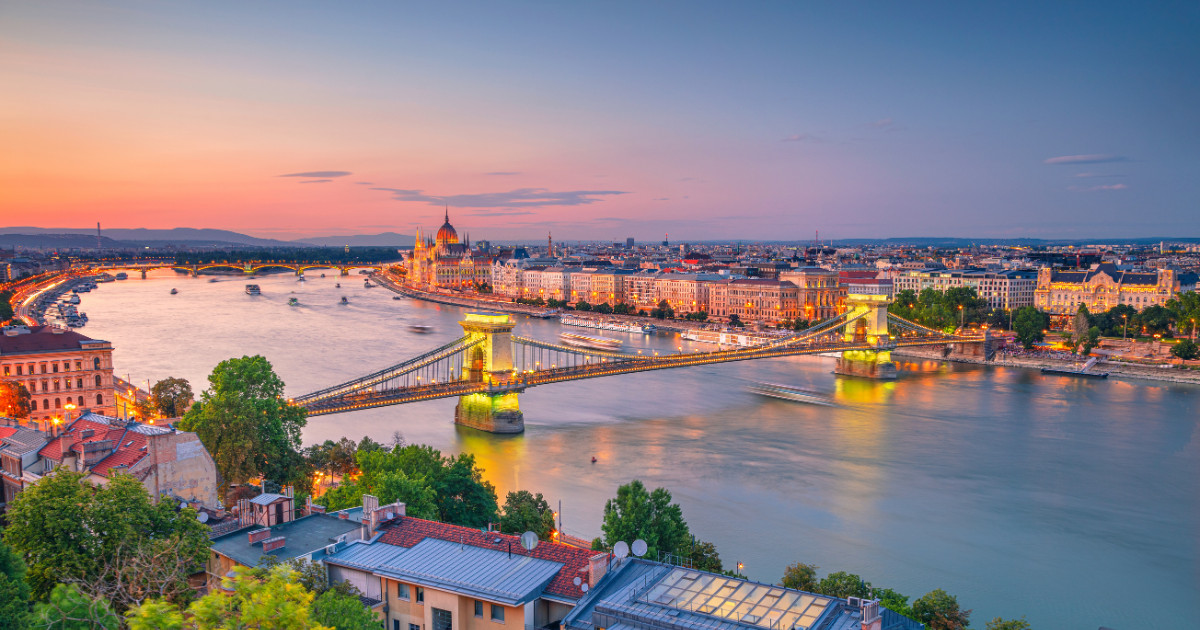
[{"x1": 295, "y1": 336, "x2": 955, "y2": 415}]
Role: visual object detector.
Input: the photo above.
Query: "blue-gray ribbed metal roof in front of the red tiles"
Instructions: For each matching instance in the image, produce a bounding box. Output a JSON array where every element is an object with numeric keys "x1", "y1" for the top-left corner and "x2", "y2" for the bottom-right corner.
[{"x1": 372, "y1": 538, "x2": 563, "y2": 606}]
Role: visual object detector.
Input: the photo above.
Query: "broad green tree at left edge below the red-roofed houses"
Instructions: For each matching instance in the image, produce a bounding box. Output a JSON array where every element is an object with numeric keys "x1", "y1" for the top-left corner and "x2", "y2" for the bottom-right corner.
[{"x1": 4, "y1": 469, "x2": 209, "y2": 605}]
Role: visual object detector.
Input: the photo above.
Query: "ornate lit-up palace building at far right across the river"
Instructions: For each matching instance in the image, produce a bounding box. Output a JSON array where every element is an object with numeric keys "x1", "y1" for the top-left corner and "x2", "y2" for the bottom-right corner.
[{"x1": 1034, "y1": 263, "x2": 1196, "y2": 316}]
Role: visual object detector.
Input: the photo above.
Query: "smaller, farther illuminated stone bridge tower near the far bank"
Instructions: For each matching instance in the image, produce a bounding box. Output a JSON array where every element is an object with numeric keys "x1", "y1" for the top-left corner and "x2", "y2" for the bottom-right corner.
[{"x1": 834, "y1": 283, "x2": 896, "y2": 379}]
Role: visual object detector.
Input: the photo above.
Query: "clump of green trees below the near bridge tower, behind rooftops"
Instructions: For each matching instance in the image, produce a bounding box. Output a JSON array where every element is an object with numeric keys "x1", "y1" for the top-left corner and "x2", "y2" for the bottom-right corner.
[{"x1": 322, "y1": 444, "x2": 497, "y2": 527}]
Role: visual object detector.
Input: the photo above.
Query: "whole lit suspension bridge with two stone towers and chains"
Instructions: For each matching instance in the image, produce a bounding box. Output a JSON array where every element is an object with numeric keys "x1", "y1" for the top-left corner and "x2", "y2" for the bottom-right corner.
[{"x1": 290, "y1": 294, "x2": 988, "y2": 433}]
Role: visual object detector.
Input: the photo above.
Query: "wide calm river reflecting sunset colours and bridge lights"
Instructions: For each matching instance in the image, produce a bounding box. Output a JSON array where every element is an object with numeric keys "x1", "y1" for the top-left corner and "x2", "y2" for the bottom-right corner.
[{"x1": 80, "y1": 271, "x2": 1200, "y2": 630}]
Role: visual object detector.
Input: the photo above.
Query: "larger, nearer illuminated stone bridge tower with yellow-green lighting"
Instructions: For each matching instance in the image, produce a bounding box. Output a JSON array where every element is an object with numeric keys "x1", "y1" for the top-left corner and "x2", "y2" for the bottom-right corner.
[{"x1": 454, "y1": 312, "x2": 524, "y2": 433}]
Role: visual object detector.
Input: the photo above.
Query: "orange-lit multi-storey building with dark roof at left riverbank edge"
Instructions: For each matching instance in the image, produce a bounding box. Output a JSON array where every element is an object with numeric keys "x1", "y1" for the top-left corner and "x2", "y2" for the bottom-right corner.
[{"x1": 0, "y1": 326, "x2": 116, "y2": 430}]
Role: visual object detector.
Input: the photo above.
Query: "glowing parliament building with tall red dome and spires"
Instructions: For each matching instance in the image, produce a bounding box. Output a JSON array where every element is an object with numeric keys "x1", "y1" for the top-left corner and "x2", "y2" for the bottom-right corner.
[{"x1": 404, "y1": 210, "x2": 492, "y2": 289}]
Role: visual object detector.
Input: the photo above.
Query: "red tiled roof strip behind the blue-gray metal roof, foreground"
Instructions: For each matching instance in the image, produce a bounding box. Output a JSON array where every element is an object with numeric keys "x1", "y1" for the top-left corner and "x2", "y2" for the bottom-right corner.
[{"x1": 379, "y1": 516, "x2": 600, "y2": 599}]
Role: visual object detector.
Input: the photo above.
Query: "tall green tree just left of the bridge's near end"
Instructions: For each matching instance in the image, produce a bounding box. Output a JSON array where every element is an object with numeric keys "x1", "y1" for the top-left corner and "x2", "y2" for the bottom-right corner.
[{"x1": 179, "y1": 355, "x2": 308, "y2": 484}]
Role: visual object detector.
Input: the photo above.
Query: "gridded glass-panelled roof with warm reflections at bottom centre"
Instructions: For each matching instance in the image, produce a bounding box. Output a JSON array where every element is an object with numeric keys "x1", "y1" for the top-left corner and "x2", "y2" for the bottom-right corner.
[{"x1": 641, "y1": 568, "x2": 834, "y2": 630}]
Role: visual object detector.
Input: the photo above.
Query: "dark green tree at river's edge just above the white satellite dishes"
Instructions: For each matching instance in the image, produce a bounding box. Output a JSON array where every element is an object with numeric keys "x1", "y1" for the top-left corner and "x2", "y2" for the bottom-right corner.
[{"x1": 601, "y1": 479, "x2": 690, "y2": 558}]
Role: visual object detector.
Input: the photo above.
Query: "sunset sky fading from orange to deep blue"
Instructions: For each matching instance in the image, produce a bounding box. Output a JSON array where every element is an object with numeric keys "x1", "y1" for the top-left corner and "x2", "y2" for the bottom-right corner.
[{"x1": 0, "y1": 0, "x2": 1200, "y2": 241}]
